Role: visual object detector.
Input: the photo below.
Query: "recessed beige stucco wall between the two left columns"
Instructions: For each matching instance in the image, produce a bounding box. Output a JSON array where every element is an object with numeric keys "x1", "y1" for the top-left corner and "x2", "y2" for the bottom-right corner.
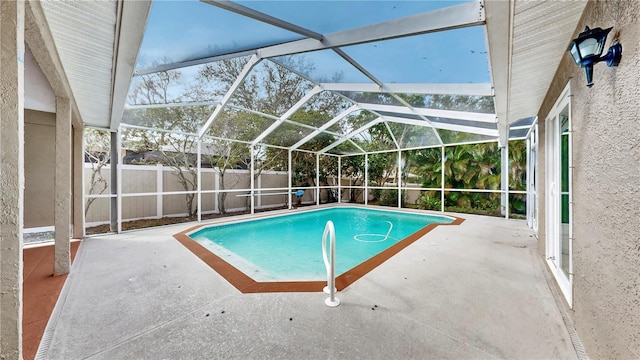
[{"x1": 24, "y1": 110, "x2": 56, "y2": 228}]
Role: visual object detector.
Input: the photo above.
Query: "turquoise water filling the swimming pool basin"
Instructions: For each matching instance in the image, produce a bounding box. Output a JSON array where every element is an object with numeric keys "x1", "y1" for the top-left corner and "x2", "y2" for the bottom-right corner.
[{"x1": 189, "y1": 207, "x2": 454, "y2": 281}]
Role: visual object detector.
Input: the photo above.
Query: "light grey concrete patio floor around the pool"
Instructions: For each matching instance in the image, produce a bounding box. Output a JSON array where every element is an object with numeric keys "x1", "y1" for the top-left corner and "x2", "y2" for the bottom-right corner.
[{"x1": 38, "y1": 210, "x2": 577, "y2": 359}]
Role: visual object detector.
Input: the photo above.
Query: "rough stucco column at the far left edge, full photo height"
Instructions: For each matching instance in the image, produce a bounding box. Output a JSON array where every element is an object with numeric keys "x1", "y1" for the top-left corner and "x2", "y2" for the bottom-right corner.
[{"x1": 0, "y1": 1, "x2": 25, "y2": 359}]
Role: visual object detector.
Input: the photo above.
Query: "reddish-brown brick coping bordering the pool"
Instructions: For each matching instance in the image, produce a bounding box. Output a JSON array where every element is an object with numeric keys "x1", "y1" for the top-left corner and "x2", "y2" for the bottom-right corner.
[{"x1": 173, "y1": 209, "x2": 464, "y2": 294}]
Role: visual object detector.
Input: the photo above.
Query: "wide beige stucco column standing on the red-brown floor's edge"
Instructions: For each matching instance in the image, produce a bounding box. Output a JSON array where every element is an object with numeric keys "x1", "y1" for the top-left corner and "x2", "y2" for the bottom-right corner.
[{"x1": 53, "y1": 97, "x2": 71, "y2": 275}]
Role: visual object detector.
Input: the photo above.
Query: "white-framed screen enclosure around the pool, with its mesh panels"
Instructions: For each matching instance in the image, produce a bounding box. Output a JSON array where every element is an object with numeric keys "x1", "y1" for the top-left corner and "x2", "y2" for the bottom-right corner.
[{"x1": 70, "y1": 1, "x2": 576, "y2": 230}]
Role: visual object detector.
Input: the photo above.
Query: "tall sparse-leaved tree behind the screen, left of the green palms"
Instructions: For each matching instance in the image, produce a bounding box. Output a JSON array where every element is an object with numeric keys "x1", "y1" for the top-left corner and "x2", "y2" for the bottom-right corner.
[{"x1": 199, "y1": 57, "x2": 346, "y2": 210}]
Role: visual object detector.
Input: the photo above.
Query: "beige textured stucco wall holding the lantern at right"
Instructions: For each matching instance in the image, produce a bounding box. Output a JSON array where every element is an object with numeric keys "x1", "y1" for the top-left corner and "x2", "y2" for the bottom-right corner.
[{"x1": 538, "y1": 0, "x2": 640, "y2": 359}]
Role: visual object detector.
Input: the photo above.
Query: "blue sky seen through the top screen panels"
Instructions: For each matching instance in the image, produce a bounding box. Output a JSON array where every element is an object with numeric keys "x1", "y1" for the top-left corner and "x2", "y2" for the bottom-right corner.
[{"x1": 137, "y1": 0, "x2": 490, "y2": 83}]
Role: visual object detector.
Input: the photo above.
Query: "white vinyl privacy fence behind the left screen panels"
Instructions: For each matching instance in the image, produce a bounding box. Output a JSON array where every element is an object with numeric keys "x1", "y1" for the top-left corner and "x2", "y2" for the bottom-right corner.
[{"x1": 85, "y1": 163, "x2": 302, "y2": 226}]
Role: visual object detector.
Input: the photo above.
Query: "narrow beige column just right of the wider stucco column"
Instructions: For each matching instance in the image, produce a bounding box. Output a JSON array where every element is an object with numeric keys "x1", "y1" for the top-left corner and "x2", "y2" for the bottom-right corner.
[{"x1": 73, "y1": 127, "x2": 85, "y2": 239}]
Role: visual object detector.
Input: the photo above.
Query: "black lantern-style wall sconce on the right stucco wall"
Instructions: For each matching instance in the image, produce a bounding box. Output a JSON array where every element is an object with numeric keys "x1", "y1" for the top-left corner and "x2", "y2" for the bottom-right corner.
[{"x1": 567, "y1": 26, "x2": 622, "y2": 87}]
